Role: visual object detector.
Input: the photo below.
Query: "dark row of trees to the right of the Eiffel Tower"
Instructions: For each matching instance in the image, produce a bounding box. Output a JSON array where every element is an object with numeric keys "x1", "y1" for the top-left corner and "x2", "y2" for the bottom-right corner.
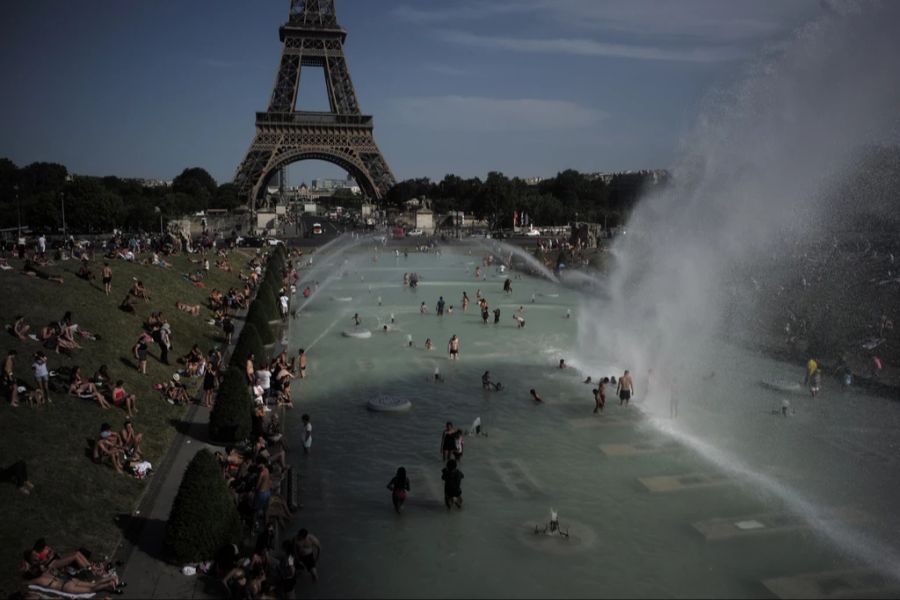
[{"x1": 385, "y1": 169, "x2": 668, "y2": 229}]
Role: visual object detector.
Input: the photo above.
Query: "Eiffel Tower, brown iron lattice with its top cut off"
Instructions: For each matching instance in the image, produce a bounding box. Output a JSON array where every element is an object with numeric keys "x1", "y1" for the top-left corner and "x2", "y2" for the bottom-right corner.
[{"x1": 234, "y1": 0, "x2": 394, "y2": 209}]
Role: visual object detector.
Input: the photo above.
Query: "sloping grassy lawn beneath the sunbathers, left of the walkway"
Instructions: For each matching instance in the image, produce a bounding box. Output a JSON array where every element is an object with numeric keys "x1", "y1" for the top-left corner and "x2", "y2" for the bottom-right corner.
[{"x1": 0, "y1": 250, "x2": 253, "y2": 597}]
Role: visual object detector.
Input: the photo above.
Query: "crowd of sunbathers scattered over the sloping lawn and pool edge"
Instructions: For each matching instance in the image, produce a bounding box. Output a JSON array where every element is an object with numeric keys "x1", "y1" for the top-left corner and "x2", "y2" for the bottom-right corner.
[{"x1": 0, "y1": 229, "x2": 318, "y2": 597}]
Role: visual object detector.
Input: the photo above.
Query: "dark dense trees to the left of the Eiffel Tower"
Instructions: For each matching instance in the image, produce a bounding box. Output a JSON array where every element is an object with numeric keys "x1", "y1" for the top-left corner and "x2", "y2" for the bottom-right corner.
[{"x1": 0, "y1": 158, "x2": 244, "y2": 233}]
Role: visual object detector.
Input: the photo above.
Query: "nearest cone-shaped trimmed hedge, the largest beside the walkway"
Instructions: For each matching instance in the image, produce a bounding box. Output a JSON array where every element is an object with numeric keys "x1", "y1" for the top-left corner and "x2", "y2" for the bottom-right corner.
[{"x1": 164, "y1": 450, "x2": 243, "y2": 564}]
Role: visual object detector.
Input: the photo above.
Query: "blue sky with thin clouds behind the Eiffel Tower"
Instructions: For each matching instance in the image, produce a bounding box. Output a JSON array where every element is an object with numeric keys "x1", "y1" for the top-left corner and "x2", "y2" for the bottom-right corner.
[{"x1": 0, "y1": 0, "x2": 819, "y2": 182}]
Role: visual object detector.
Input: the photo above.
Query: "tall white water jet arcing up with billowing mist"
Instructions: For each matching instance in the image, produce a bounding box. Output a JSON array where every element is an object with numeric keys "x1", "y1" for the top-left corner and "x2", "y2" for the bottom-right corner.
[{"x1": 577, "y1": 3, "x2": 900, "y2": 574}]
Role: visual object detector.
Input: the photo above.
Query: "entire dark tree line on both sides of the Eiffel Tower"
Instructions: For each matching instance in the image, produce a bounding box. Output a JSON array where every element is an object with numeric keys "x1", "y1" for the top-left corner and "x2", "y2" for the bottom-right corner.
[{"x1": 0, "y1": 158, "x2": 668, "y2": 233}]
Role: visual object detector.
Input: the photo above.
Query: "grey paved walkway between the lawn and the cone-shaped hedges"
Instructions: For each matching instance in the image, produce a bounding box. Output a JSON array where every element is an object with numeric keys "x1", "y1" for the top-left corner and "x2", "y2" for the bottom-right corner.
[{"x1": 116, "y1": 310, "x2": 287, "y2": 598}]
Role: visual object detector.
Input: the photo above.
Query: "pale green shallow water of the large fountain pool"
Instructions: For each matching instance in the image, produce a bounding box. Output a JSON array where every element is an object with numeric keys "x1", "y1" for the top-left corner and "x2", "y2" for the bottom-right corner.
[{"x1": 289, "y1": 250, "x2": 900, "y2": 597}]
